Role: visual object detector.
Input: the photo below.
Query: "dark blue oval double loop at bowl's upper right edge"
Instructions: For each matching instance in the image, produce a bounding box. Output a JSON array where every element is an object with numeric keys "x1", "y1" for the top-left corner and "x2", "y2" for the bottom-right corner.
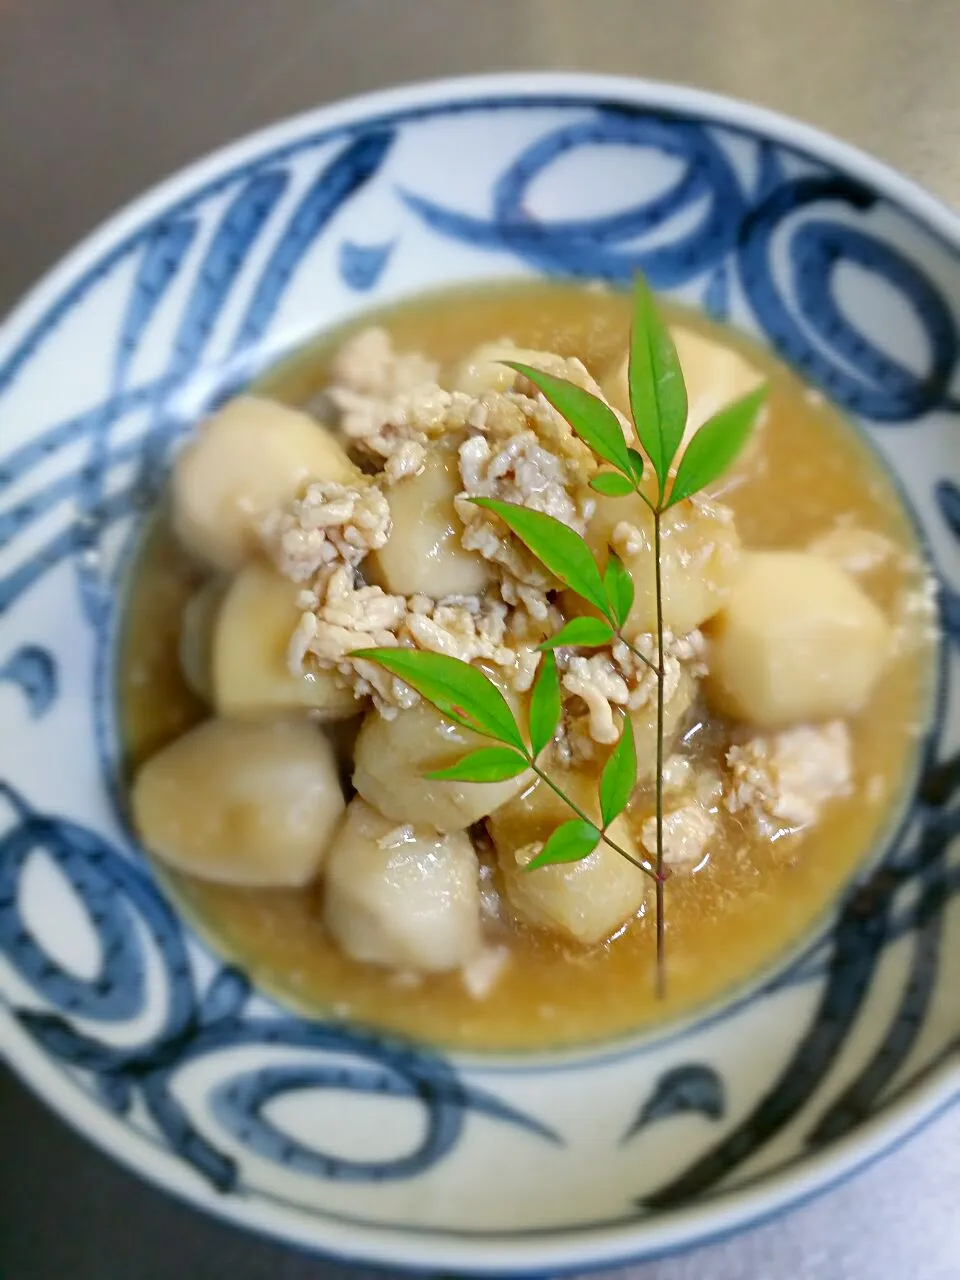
[{"x1": 737, "y1": 175, "x2": 957, "y2": 424}]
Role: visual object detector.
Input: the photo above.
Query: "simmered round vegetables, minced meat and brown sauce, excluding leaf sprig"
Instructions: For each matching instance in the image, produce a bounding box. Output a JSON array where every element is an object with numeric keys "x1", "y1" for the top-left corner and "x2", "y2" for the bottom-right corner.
[{"x1": 120, "y1": 284, "x2": 933, "y2": 1050}]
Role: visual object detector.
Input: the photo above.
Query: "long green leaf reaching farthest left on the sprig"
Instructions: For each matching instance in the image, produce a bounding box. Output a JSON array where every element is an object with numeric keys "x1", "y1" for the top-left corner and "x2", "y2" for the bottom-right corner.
[{"x1": 351, "y1": 648, "x2": 526, "y2": 751}]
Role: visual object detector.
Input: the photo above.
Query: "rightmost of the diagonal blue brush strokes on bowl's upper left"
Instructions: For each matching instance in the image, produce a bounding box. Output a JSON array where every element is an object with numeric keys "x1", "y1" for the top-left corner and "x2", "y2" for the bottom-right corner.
[{"x1": 232, "y1": 129, "x2": 397, "y2": 352}]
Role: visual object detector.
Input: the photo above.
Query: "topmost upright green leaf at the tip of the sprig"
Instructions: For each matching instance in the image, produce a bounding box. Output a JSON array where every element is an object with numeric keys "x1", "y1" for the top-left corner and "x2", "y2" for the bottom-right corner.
[{"x1": 627, "y1": 276, "x2": 687, "y2": 499}]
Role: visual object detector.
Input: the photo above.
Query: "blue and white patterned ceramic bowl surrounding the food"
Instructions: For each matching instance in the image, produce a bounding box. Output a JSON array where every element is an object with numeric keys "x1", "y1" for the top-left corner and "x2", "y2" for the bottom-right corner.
[{"x1": 0, "y1": 76, "x2": 960, "y2": 1272}]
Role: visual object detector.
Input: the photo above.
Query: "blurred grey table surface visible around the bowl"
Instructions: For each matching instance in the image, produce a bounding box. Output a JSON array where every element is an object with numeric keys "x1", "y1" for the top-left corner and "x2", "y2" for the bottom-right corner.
[{"x1": 0, "y1": 0, "x2": 960, "y2": 1280}]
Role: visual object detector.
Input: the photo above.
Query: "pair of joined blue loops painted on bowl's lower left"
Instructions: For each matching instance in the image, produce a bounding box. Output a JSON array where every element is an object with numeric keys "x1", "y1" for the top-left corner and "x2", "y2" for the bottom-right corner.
[{"x1": 0, "y1": 783, "x2": 561, "y2": 1190}]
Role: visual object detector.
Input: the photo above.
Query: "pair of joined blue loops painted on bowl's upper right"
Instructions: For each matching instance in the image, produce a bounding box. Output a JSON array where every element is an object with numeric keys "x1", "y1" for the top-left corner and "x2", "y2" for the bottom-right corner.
[{"x1": 403, "y1": 111, "x2": 957, "y2": 424}]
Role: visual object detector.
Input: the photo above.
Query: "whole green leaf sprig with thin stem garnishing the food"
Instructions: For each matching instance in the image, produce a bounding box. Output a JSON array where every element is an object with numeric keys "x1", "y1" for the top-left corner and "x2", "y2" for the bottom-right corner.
[{"x1": 353, "y1": 279, "x2": 765, "y2": 995}]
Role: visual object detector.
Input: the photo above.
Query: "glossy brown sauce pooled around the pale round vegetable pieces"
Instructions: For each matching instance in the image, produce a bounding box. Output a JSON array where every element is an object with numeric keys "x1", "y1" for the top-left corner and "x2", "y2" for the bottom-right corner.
[{"x1": 119, "y1": 284, "x2": 932, "y2": 1051}]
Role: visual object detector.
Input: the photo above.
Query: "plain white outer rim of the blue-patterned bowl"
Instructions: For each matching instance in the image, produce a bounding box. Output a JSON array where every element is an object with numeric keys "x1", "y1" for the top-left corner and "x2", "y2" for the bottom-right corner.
[{"x1": 0, "y1": 70, "x2": 960, "y2": 1275}]
